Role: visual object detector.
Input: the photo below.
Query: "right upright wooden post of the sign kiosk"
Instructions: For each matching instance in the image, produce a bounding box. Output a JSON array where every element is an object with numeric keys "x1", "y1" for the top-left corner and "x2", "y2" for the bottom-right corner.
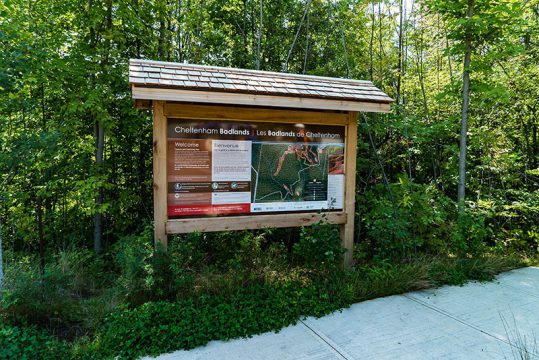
[{"x1": 341, "y1": 112, "x2": 357, "y2": 267}]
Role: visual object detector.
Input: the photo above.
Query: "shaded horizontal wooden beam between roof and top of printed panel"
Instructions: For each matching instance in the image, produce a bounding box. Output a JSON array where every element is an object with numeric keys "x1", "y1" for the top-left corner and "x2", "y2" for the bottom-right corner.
[{"x1": 165, "y1": 102, "x2": 349, "y2": 125}]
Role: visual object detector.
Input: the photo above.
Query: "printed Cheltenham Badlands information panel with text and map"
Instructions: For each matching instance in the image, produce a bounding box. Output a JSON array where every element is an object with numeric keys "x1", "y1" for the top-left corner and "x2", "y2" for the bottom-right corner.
[{"x1": 167, "y1": 119, "x2": 344, "y2": 216}]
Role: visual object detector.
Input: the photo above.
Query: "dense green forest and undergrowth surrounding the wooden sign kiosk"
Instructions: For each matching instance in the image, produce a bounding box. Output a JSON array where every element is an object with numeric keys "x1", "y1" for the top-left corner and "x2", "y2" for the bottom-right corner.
[{"x1": 0, "y1": 0, "x2": 539, "y2": 356}]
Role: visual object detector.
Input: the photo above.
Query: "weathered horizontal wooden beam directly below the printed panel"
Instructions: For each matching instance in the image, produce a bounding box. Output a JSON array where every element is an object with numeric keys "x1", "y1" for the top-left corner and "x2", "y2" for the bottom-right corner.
[{"x1": 166, "y1": 212, "x2": 347, "y2": 234}]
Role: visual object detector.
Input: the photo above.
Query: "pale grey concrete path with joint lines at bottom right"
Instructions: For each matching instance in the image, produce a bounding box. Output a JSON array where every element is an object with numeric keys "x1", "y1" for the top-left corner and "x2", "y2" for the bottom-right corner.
[{"x1": 150, "y1": 267, "x2": 539, "y2": 360}]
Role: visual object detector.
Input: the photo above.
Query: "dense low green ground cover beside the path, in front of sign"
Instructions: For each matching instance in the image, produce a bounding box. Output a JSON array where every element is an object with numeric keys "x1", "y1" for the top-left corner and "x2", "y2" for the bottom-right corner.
[{"x1": 99, "y1": 283, "x2": 347, "y2": 358}]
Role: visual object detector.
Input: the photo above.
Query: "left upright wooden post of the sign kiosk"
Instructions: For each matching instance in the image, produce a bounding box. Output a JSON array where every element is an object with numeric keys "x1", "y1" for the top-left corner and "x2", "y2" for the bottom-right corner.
[{"x1": 153, "y1": 101, "x2": 168, "y2": 251}]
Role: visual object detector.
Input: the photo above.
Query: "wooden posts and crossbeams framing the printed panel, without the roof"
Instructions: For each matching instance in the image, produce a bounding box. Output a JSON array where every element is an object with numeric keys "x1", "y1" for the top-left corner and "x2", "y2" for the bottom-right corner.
[{"x1": 152, "y1": 100, "x2": 357, "y2": 266}]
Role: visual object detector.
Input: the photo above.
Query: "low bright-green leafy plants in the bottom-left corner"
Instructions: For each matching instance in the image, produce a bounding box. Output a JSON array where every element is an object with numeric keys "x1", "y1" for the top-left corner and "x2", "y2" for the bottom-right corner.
[{"x1": 0, "y1": 324, "x2": 70, "y2": 360}]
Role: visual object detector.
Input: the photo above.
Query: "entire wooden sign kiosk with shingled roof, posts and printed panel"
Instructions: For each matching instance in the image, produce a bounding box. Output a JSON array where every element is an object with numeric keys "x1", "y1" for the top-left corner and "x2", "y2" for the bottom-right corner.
[{"x1": 129, "y1": 60, "x2": 393, "y2": 266}]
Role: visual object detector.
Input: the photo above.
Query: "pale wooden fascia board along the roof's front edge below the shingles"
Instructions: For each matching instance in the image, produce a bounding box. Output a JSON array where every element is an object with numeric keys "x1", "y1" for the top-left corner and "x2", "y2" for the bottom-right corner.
[{"x1": 131, "y1": 86, "x2": 391, "y2": 113}]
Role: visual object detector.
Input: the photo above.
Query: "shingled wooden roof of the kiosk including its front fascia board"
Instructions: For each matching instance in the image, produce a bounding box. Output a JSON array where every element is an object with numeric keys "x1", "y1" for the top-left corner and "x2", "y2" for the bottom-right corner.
[{"x1": 129, "y1": 60, "x2": 393, "y2": 113}]
